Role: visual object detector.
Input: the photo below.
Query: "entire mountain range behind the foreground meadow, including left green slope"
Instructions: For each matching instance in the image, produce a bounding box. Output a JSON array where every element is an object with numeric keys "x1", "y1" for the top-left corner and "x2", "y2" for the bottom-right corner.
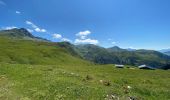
[{"x1": 0, "y1": 28, "x2": 170, "y2": 69}]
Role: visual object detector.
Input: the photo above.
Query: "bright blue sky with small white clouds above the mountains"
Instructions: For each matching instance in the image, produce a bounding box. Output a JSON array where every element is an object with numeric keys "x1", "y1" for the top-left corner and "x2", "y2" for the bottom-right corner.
[{"x1": 0, "y1": 0, "x2": 170, "y2": 50}]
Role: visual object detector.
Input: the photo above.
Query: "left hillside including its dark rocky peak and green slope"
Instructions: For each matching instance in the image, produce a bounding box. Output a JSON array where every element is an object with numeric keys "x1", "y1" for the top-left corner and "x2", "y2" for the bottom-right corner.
[{"x1": 0, "y1": 28, "x2": 90, "y2": 65}]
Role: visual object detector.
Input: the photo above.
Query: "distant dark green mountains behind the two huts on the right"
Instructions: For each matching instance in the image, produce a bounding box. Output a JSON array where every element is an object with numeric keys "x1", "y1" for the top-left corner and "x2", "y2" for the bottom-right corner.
[{"x1": 77, "y1": 45, "x2": 170, "y2": 68}]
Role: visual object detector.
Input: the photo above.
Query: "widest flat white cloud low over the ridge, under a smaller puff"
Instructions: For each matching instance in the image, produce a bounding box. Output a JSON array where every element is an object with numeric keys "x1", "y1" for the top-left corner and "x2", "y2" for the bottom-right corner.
[{"x1": 75, "y1": 38, "x2": 99, "y2": 44}]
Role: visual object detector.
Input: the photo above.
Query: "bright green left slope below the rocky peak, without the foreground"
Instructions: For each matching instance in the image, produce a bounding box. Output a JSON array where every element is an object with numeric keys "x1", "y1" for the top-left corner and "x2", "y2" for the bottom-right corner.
[{"x1": 0, "y1": 37, "x2": 90, "y2": 65}]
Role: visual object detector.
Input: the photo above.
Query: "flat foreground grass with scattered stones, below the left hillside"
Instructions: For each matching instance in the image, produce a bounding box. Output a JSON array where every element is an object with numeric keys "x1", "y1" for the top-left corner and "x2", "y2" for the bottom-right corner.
[{"x1": 0, "y1": 64, "x2": 170, "y2": 100}]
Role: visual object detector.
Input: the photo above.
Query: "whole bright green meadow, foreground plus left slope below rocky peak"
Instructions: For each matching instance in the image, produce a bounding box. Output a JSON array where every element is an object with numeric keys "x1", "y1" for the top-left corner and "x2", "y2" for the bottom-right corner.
[{"x1": 0, "y1": 37, "x2": 170, "y2": 100}]
